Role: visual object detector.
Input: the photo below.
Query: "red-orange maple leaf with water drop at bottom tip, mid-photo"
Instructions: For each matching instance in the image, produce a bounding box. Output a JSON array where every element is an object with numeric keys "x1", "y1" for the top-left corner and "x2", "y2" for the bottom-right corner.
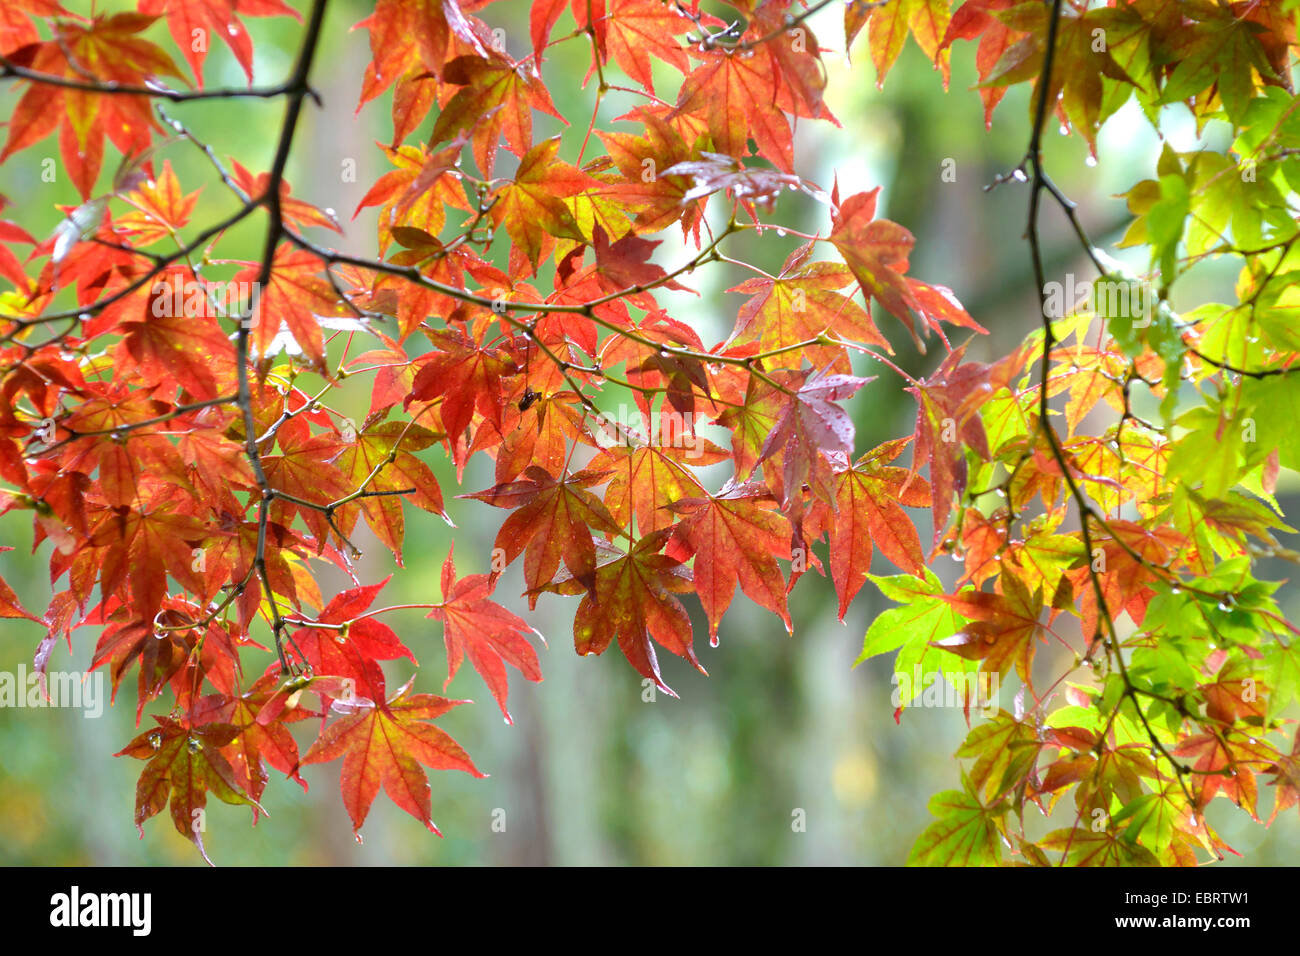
[{"x1": 664, "y1": 484, "x2": 794, "y2": 645}]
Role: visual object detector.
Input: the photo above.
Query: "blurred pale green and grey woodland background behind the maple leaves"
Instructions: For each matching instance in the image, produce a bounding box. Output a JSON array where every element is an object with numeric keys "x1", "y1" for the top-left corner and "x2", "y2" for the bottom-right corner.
[{"x1": 0, "y1": 0, "x2": 1300, "y2": 865}]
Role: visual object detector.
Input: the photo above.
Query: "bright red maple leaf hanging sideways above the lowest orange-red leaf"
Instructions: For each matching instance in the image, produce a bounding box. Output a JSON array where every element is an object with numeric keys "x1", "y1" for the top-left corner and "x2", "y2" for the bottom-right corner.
[{"x1": 429, "y1": 549, "x2": 542, "y2": 723}]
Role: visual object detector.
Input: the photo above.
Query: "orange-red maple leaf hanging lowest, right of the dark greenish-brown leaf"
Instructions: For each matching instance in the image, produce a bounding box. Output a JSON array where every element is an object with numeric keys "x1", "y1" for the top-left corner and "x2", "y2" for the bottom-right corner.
[{"x1": 302, "y1": 678, "x2": 486, "y2": 836}]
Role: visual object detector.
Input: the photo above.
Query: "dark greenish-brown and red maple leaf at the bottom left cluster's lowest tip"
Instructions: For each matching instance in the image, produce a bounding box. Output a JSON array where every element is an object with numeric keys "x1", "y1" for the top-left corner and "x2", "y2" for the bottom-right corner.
[{"x1": 116, "y1": 717, "x2": 265, "y2": 866}]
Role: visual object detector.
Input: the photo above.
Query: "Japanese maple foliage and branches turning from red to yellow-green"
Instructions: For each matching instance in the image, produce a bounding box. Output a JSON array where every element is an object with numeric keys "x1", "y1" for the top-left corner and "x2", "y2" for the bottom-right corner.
[{"x1": 0, "y1": 0, "x2": 1300, "y2": 865}]
